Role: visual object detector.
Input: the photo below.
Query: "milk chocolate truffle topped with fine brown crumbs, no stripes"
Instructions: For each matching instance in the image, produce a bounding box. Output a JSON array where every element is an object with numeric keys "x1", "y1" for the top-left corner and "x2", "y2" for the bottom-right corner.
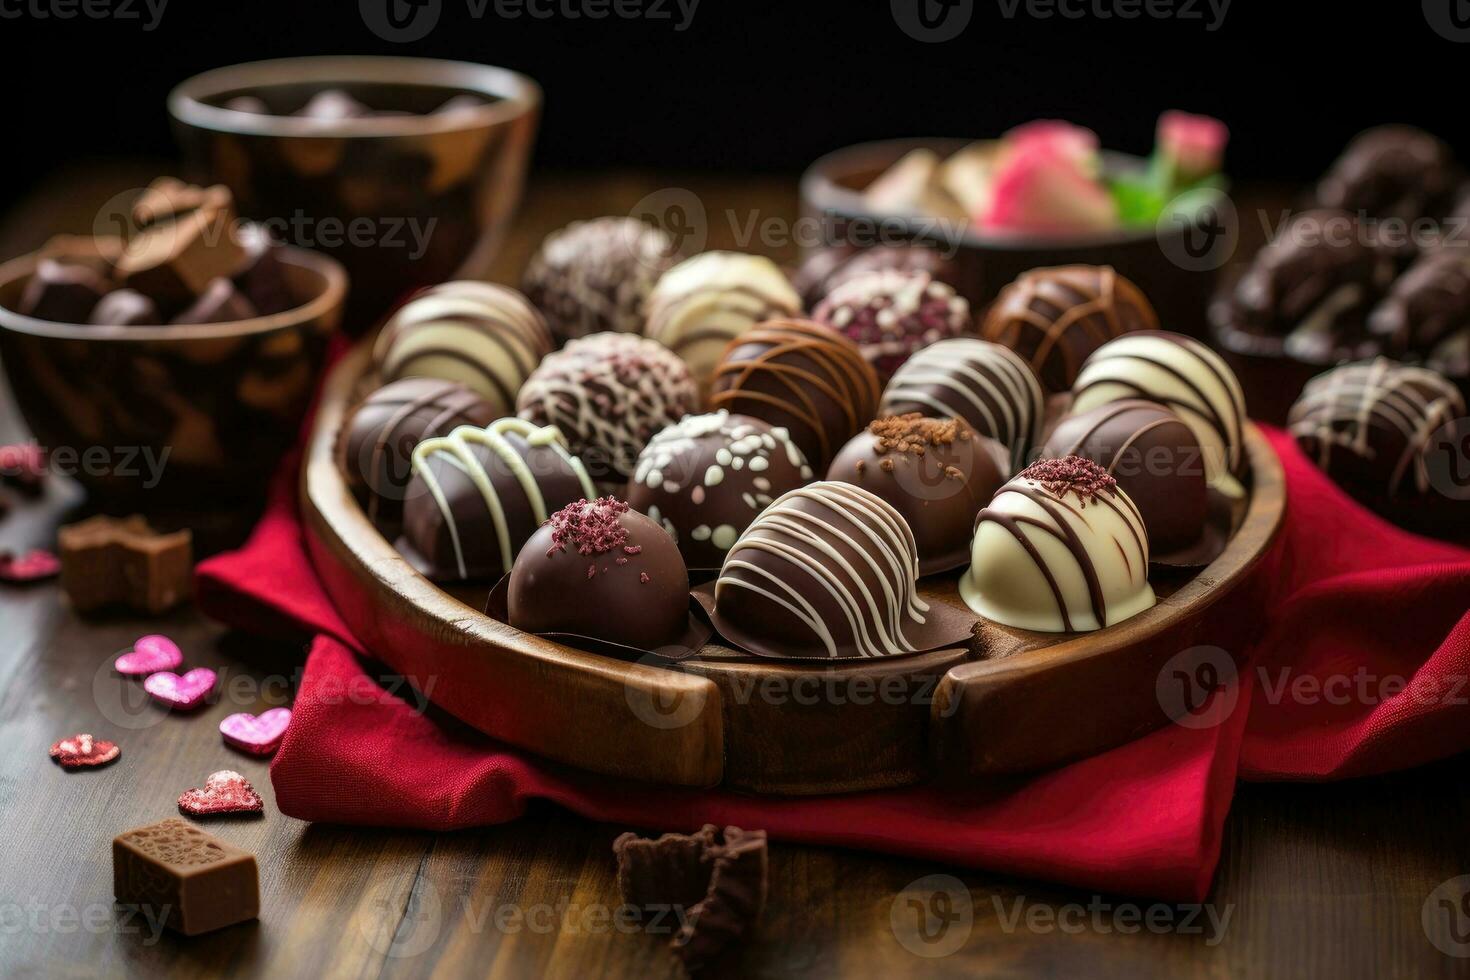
[{"x1": 828, "y1": 413, "x2": 1010, "y2": 574}]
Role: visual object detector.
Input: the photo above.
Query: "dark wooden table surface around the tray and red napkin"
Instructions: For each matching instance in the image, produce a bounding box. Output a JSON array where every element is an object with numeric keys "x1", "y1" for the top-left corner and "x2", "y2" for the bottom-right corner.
[{"x1": 0, "y1": 167, "x2": 1470, "y2": 980}]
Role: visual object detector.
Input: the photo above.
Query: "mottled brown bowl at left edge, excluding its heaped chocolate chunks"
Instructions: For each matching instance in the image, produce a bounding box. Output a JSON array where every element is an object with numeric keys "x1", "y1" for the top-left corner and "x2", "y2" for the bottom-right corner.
[{"x1": 0, "y1": 239, "x2": 347, "y2": 511}]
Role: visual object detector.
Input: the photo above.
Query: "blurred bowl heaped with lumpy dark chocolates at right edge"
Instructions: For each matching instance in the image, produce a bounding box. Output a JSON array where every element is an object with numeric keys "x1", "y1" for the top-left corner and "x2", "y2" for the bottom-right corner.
[{"x1": 1210, "y1": 125, "x2": 1470, "y2": 425}]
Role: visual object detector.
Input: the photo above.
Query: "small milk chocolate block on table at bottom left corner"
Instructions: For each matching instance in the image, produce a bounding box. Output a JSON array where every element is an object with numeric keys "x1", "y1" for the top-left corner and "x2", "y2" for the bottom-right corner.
[{"x1": 112, "y1": 817, "x2": 260, "y2": 936}]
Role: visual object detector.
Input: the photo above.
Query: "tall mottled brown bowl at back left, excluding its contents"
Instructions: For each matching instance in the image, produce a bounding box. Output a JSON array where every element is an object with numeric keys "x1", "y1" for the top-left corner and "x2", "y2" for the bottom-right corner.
[{"x1": 169, "y1": 57, "x2": 541, "y2": 335}]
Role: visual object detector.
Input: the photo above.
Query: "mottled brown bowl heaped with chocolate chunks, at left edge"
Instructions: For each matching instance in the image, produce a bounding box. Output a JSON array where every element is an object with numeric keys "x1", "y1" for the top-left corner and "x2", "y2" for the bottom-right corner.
[{"x1": 0, "y1": 178, "x2": 347, "y2": 505}]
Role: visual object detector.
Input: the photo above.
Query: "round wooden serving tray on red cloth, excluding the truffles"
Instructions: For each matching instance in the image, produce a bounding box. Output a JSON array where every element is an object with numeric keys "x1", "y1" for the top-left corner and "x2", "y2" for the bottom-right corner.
[{"x1": 301, "y1": 345, "x2": 1285, "y2": 795}]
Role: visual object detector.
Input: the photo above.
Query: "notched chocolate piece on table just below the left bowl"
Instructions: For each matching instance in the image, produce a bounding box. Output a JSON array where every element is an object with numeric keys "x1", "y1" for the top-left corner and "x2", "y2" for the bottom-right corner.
[{"x1": 57, "y1": 514, "x2": 194, "y2": 614}]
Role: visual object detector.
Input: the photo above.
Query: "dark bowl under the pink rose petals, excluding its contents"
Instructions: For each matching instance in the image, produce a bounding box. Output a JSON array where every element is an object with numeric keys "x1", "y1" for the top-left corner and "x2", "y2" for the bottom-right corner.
[{"x1": 801, "y1": 138, "x2": 1232, "y2": 339}]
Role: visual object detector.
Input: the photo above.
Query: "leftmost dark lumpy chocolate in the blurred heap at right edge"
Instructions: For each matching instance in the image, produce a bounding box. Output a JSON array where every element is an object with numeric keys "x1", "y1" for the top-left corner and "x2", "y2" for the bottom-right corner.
[{"x1": 1211, "y1": 210, "x2": 1394, "y2": 360}]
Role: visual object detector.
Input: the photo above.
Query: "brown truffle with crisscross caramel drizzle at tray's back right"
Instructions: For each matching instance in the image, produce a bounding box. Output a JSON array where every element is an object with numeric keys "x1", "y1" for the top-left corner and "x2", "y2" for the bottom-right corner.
[{"x1": 980, "y1": 266, "x2": 1158, "y2": 394}]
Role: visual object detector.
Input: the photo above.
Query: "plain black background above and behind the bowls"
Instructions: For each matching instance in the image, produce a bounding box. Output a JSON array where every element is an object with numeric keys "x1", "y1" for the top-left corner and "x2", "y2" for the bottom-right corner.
[{"x1": 0, "y1": 0, "x2": 1470, "y2": 209}]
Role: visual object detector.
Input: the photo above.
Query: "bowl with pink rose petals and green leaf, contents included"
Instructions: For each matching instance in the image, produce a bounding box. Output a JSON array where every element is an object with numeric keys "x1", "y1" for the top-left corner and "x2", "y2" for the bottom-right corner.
[{"x1": 797, "y1": 112, "x2": 1233, "y2": 336}]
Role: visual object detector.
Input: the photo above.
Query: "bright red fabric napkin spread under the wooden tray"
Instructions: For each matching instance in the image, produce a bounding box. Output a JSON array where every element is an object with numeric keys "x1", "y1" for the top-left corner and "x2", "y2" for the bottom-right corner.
[{"x1": 198, "y1": 432, "x2": 1470, "y2": 901}]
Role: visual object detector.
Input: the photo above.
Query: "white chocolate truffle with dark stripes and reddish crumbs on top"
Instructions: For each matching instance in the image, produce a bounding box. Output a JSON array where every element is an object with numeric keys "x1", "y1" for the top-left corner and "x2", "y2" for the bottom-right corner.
[{"x1": 960, "y1": 455, "x2": 1155, "y2": 633}]
